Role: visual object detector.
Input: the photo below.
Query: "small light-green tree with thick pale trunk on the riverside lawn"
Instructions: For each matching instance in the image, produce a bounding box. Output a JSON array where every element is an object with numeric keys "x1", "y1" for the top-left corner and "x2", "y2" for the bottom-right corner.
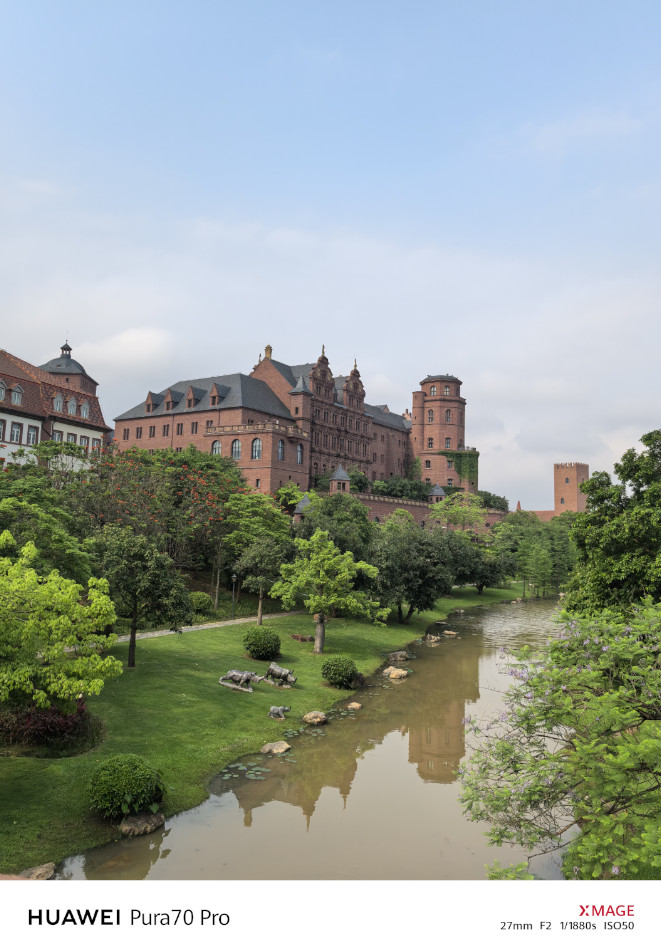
[{"x1": 270, "y1": 529, "x2": 388, "y2": 654}]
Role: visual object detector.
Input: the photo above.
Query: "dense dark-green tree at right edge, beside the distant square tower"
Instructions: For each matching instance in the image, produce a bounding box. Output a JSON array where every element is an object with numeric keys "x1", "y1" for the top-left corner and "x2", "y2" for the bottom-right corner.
[{"x1": 567, "y1": 429, "x2": 661, "y2": 611}]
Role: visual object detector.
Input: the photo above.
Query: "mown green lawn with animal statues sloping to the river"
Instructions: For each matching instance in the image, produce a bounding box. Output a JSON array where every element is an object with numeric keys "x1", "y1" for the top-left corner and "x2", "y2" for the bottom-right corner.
[{"x1": 0, "y1": 585, "x2": 520, "y2": 873}]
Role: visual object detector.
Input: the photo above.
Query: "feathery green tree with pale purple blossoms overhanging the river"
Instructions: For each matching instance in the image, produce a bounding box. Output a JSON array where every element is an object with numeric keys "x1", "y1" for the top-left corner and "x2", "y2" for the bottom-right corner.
[{"x1": 462, "y1": 599, "x2": 661, "y2": 879}]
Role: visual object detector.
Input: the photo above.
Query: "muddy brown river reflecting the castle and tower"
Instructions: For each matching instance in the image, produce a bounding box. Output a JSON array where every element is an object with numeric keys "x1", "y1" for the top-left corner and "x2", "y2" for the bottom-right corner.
[{"x1": 58, "y1": 602, "x2": 561, "y2": 880}]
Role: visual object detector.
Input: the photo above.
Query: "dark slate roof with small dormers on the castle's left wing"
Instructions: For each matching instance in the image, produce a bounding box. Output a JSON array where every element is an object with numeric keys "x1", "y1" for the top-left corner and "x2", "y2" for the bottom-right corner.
[{"x1": 115, "y1": 373, "x2": 292, "y2": 420}]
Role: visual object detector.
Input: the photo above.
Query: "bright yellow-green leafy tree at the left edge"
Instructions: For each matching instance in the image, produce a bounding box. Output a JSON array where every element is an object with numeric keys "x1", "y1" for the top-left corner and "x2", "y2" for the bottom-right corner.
[{"x1": 0, "y1": 531, "x2": 121, "y2": 708}]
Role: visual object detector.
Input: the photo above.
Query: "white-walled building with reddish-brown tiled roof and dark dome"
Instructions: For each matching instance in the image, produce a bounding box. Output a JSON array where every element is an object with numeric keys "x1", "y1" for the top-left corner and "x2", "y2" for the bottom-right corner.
[{"x1": 0, "y1": 343, "x2": 110, "y2": 465}]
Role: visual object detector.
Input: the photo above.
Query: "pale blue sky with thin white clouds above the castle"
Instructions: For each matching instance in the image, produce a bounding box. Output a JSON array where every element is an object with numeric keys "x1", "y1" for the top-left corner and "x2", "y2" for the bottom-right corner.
[{"x1": 0, "y1": 0, "x2": 661, "y2": 509}]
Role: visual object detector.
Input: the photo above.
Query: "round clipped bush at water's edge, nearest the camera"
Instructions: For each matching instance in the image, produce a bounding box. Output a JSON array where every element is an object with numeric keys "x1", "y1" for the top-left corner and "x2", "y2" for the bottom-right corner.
[{"x1": 89, "y1": 753, "x2": 165, "y2": 819}]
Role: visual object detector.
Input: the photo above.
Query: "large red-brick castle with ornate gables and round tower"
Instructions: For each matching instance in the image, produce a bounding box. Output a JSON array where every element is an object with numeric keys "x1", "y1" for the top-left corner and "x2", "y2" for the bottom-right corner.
[{"x1": 115, "y1": 346, "x2": 478, "y2": 493}]
